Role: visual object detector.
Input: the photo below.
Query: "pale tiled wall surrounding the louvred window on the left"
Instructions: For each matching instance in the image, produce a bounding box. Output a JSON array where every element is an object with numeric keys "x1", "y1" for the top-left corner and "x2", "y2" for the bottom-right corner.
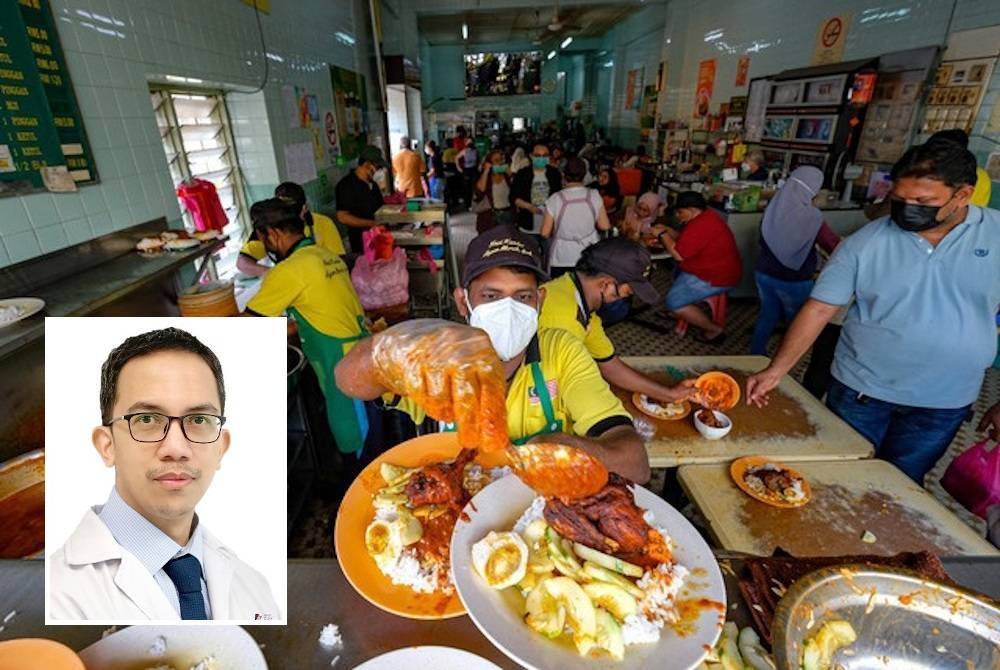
[{"x1": 0, "y1": 0, "x2": 375, "y2": 266}]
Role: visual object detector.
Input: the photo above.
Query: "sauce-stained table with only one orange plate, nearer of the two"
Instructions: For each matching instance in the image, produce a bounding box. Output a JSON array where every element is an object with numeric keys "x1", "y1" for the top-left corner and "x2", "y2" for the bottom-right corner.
[{"x1": 677, "y1": 459, "x2": 1000, "y2": 557}]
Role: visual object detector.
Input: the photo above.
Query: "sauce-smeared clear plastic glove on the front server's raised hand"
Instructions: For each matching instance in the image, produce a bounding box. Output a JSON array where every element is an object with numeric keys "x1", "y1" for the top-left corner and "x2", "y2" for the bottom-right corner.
[{"x1": 372, "y1": 319, "x2": 510, "y2": 451}]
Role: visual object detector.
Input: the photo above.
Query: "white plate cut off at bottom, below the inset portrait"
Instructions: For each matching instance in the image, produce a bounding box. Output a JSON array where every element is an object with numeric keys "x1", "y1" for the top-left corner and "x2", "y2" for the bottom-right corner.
[{"x1": 80, "y1": 626, "x2": 267, "y2": 670}]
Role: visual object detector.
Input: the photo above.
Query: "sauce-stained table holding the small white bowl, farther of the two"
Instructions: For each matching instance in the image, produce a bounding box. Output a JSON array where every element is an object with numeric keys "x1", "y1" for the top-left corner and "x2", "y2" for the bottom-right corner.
[{"x1": 613, "y1": 356, "x2": 874, "y2": 468}]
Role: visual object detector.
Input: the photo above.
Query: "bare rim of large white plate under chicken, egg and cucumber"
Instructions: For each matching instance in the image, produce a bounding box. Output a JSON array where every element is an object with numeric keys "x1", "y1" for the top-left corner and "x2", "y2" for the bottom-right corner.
[{"x1": 451, "y1": 476, "x2": 726, "y2": 670}]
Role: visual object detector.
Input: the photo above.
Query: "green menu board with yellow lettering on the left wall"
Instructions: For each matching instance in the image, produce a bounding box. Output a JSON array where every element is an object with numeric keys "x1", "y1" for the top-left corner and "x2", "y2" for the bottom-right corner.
[{"x1": 0, "y1": 0, "x2": 97, "y2": 196}]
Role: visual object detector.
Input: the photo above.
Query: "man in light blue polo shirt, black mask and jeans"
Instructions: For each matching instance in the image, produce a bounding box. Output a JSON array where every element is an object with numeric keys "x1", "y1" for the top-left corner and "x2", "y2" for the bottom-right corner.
[{"x1": 747, "y1": 141, "x2": 1000, "y2": 484}]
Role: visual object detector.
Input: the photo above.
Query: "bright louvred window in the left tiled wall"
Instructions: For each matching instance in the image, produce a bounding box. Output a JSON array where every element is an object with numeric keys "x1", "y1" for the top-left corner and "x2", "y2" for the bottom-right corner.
[{"x1": 150, "y1": 88, "x2": 249, "y2": 277}]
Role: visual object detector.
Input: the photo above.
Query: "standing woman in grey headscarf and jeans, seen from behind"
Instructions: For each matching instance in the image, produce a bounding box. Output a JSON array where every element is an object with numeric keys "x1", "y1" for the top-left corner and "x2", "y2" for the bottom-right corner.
[{"x1": 750, "y1": 165, "x2": 840, "y2": 355}]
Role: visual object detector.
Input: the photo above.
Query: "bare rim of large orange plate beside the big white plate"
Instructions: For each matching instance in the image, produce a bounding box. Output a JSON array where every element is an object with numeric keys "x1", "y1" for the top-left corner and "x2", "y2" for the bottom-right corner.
[{"x1": 333, "y1": 433, "x2": 507, "y2": 619}]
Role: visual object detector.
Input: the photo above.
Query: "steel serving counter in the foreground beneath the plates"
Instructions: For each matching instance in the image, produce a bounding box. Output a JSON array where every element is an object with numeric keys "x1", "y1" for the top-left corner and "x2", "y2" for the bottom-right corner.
[{"x1": 0, "y1": 552, "x2": 1000, "y2": 670}]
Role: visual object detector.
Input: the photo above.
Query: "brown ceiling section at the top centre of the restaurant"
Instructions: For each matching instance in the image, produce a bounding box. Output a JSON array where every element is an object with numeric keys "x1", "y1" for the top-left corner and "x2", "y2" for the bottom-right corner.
[{"x1": 417, "y1": 3, "x2": 642, "y2": 46}]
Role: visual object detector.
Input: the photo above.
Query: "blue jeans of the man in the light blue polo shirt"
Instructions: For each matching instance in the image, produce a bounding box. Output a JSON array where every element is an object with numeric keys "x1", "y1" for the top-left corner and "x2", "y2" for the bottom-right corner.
[{"x1": 826, "y1": 377, "x2": 972, "y2": 486}]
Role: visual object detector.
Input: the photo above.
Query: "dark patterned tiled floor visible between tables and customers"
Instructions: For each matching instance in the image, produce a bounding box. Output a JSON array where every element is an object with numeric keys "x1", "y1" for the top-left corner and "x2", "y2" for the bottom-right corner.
[{"x1": 288, "y1": 273, "x2": 1000, "y2": 557}]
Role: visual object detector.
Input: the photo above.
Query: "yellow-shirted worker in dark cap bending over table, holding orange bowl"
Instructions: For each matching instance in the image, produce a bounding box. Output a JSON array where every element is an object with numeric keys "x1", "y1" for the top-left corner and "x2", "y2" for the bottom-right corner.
[{"x1": 538, "y1": 237, "x2": 694, "y2": 402}]
